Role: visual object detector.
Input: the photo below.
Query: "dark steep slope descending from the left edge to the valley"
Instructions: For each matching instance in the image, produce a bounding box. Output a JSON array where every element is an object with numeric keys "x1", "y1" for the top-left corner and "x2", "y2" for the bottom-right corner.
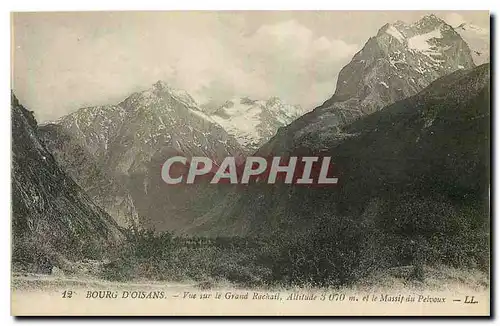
[{"x1": 11, "y1": 96, "x2": 123, "y2": 268}]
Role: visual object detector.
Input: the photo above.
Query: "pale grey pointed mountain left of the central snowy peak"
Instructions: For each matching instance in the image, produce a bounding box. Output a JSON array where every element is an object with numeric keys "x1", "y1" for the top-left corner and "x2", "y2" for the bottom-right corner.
[{"x1": 41, "y1": 81, "x2": 244, "y2": 229}]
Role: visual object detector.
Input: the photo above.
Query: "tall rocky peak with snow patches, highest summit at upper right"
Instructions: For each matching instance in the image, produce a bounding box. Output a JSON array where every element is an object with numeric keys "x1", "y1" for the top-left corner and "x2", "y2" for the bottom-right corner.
[{"x1": 260, "y1": 15, "x2": 474, "y2": 154}]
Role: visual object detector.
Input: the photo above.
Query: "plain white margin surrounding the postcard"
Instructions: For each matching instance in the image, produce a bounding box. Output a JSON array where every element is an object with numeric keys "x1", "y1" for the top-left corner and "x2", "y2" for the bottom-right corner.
[{"x1": 0, "y1": 0, "x2": 500, "y2": 325}]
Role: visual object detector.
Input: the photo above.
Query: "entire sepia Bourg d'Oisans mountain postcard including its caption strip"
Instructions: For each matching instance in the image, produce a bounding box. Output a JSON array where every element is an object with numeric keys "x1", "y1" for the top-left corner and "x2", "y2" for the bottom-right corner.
[{"x1": 10, "y1": 10, "x2": 491, "y2": 316}]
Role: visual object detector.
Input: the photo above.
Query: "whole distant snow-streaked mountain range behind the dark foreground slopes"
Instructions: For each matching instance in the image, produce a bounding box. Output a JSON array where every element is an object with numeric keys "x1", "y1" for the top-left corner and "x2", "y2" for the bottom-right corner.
[{"x1": 29, "y1": 15, "x2": 490, "y2": 235}]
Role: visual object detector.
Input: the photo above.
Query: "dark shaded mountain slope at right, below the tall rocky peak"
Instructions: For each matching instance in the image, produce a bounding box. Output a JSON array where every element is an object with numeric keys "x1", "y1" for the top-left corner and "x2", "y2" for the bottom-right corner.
[{"x1": 188, "y1": 64, "x2": 490, "y2": 236}]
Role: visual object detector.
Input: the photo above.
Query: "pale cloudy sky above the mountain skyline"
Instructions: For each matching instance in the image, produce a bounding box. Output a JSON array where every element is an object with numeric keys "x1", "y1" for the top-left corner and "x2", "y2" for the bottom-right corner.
[{"x1": 12, "y1": 11, "x2": 489, "y2": 121}]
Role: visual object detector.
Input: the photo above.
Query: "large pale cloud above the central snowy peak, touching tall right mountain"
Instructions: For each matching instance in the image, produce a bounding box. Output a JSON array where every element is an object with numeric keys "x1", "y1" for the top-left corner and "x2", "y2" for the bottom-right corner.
[{"x1": 191, "y1": 20, "x2": 359, "y2": 109}]
